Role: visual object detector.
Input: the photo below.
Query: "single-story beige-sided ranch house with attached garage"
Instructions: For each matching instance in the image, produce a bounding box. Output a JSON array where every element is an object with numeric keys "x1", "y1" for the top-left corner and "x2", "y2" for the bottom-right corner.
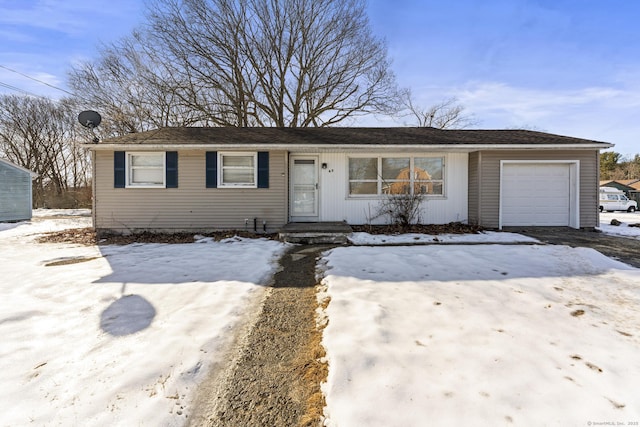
[{"x1": 87, "y1": 127, "x2": 613, "y2": 233}]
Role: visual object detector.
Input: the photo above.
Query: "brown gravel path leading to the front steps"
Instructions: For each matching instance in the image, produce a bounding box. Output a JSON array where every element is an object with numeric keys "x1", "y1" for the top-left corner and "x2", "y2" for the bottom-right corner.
[{"x1": 190, "y1": 246, "x2": 330, "y2": 427}]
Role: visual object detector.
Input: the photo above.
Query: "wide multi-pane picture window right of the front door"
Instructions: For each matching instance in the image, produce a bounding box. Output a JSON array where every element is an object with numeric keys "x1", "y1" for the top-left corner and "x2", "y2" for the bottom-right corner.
[{"x1": 349, "y1": 156, "x2": 444, "y2": 197}]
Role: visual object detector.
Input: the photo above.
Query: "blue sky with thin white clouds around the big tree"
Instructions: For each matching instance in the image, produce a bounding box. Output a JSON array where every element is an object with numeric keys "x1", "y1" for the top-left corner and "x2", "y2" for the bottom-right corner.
[{"x1": 0, "y1": 0, "x2": 640, "y2": 156}]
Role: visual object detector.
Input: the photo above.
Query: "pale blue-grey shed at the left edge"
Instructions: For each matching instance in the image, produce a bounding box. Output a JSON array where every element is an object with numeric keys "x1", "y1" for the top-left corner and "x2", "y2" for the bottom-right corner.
[{"x1": 0, "y1": 158, "x2": 37, "y2": 222}]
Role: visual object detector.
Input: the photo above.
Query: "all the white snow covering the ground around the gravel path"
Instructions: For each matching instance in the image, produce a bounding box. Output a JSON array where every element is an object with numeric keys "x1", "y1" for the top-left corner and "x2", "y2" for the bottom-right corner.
[{"x1": 0, "y1": 210, "x2": 640, "y2": 427}]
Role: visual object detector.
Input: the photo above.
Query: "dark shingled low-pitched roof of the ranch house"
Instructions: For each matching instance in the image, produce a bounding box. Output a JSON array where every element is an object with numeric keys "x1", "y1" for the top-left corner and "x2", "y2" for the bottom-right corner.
[{"x1": 91, "y1": 127, "x2": 612, "y2": 149}]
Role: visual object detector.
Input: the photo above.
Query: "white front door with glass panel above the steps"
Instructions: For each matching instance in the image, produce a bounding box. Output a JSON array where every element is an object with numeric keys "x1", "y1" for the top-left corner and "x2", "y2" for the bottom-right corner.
[{"x1": 290, "y1": 156, "x2": 318, "y2": 222}]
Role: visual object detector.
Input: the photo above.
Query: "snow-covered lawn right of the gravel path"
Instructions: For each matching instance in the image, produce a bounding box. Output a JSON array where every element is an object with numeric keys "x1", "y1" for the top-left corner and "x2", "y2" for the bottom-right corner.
[{"x1": 321, "y1": 245, "x2": 640, "y2": 427}]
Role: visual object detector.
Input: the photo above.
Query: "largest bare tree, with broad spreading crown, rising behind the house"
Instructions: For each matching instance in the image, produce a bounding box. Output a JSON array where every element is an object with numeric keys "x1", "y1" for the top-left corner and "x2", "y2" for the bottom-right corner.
[{"x1": 71, "y1": 0, "x2": 398, "y2": 131}]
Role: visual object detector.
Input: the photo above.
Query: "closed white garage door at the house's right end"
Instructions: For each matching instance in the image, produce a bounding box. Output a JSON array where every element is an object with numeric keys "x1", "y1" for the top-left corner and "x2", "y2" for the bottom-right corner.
[{"x1": 501, "y1": 163, "x2": 571, "y2": 226}]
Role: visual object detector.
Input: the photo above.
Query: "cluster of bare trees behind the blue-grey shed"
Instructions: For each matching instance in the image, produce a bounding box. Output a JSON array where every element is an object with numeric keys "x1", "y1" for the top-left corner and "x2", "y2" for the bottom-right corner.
[{"x1": 0, "y1": 95, "x2": 90, "y2": 207}]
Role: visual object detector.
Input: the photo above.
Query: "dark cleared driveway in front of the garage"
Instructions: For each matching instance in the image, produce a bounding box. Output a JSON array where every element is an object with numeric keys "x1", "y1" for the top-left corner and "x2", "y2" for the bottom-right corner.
[{"x1": 504, "y1": 227, "x2": 640, "y2": 268}]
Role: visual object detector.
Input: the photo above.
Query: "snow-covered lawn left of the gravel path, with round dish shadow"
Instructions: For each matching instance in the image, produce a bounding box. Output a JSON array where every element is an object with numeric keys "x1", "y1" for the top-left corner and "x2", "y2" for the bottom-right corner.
[{"x1": 0, "y1": 211, "x2": 284, "y2": 426}]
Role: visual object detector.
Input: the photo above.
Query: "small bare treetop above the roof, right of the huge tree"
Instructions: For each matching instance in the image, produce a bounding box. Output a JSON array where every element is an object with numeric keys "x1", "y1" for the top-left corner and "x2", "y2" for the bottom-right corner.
[{"x1": 402, "y1": 91, "x2": 478, "y2": 129}]
